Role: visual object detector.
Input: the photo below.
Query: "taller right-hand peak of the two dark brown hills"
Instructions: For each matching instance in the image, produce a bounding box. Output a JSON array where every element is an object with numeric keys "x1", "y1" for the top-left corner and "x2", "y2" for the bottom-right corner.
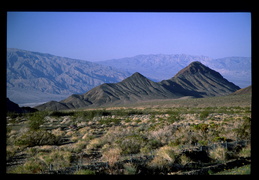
[{"x1": 161, "y1": 61, "x2": 240, "y2": 97}]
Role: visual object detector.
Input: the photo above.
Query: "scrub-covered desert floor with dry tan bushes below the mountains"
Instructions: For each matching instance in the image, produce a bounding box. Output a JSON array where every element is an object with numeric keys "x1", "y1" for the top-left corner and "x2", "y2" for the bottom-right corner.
[{"x1": 6, "y1": 94, "x2": 251, "y2": 175}]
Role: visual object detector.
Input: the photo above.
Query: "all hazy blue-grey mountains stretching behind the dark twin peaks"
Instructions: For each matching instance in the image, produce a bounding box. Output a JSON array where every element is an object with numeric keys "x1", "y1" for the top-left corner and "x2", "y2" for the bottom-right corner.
[{"x1": 7, "y1": 49, "x2": 251, "y2": 107}]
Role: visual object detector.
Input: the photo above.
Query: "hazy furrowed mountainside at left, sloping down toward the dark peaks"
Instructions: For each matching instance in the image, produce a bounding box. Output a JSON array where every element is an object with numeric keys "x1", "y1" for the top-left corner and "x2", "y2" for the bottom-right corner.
[{"x1": 7, "y1": 49, "x2": 129, "y2": 104}]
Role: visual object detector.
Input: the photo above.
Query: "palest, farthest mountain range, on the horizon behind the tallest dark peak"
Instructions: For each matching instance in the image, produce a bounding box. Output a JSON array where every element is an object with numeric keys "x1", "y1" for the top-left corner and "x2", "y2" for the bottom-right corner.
[{"x1": 98, "y1": 54, "x2": 251, "y2": 88}]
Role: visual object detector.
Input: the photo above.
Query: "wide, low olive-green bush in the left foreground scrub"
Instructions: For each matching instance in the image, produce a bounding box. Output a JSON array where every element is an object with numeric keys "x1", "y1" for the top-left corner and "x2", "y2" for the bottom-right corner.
[{"x1": 15, "y1": 130, "x2": 57, "y2": 147}]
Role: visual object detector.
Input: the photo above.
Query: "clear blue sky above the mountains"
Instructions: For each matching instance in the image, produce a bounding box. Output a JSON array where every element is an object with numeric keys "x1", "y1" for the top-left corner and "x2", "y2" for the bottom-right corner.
[{"x1": 7, "y1": 12, "x2": 251, "y2": 61}]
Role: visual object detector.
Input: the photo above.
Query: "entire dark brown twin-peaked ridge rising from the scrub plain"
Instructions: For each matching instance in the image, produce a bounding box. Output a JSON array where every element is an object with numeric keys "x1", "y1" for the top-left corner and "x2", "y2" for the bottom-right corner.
[{"x1": 35, "y1": 61, "x2": 240, "y2": 111}]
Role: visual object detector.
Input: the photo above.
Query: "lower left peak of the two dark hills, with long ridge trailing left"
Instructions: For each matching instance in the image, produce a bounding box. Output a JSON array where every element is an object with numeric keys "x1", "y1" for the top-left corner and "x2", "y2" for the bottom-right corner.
[{"x1": 36, "y1": 73, "x2": 182, "y2": 110}]
